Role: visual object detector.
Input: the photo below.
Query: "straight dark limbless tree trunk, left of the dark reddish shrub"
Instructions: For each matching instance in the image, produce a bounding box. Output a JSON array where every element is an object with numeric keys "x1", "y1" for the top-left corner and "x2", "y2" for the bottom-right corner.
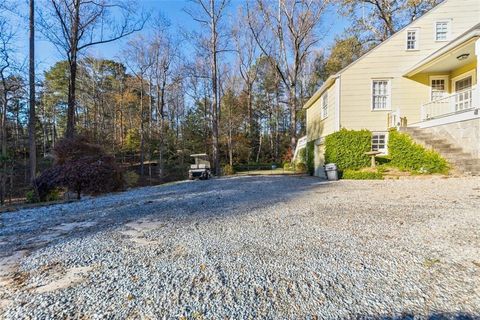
[{"x1": 28, "y1": 0, "x2": 37, "y2": 183}]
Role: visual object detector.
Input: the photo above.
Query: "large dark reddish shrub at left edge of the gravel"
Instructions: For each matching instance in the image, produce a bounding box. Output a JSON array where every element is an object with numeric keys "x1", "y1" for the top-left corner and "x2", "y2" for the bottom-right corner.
[{"x1": 35, "y1": 137, "x2": 123, "y2": 201}]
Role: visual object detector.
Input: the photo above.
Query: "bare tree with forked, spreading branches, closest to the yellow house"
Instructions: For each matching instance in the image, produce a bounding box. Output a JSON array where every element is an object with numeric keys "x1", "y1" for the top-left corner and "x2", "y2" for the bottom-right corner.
[{"x1": 247, "y1": 0, "x2": 327, "y2": 149}]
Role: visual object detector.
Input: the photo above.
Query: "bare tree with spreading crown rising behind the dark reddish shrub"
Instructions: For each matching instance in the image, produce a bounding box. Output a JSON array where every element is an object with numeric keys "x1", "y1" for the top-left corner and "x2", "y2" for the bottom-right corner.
[{"x1": 40, "y1": 0, "x2": 146, "y2": 137}]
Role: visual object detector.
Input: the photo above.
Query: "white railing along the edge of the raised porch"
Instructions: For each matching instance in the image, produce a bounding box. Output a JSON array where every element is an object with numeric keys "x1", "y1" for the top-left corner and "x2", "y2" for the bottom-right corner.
[{"x1": 421, "y1": 86, "x2": 480, "y2": 120}]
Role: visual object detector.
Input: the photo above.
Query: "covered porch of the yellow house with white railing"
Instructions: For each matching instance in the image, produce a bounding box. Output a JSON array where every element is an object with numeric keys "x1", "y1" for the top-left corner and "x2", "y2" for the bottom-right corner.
[{"x1": 404, "y1": 25, "x2": 480, "y2": 127}]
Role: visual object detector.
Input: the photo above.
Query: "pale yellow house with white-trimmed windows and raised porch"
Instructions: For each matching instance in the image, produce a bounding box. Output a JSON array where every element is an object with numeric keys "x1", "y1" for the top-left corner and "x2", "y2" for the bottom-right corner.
[{"x1": 304, "y1": 0, "x2": 480, "y2": 175}]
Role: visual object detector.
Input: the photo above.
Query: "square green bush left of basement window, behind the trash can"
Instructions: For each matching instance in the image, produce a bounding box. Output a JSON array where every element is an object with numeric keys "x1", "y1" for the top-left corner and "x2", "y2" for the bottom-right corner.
[{"x1": 325, "y1": 129, "x2": 372, "y2": 171}]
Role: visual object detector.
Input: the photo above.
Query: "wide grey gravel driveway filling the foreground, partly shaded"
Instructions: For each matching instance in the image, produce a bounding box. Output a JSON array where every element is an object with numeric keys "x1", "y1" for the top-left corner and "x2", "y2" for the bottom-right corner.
[{"x1": 0, "y1": 176, "x2": 480, "y2": 319}]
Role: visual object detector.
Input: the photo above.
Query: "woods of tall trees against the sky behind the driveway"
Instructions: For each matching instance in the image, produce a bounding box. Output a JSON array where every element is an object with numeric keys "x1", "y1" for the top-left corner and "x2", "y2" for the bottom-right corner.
[{"x1": 0, "y1": 0, "x2": 439, "y2": 204}]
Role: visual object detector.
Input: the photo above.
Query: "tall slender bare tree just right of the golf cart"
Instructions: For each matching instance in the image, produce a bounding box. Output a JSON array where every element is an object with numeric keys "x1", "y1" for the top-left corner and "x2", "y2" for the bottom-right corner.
[{"x1": 187, "y1": 0, "x2": 229, "y2": 175}]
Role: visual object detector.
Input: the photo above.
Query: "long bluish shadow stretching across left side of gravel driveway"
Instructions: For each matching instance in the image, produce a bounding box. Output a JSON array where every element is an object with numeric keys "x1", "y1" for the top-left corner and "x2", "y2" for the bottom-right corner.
[{"x1": 0, "y1": 176, "x2": 328, "y2": 258}]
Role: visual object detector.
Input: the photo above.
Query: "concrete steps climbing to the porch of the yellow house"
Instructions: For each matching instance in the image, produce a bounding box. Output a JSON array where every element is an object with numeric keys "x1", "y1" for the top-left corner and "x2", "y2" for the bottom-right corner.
[{"x1": 400, "y1": 127, "x2": 480, "y2": 175}]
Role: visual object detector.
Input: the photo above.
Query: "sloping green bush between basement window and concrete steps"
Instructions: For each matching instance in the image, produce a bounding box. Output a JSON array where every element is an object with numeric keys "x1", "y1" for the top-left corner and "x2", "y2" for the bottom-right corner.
[{"x1": 388, "y1": 130, "x2": 449, "y2": 173}]
